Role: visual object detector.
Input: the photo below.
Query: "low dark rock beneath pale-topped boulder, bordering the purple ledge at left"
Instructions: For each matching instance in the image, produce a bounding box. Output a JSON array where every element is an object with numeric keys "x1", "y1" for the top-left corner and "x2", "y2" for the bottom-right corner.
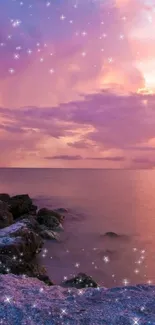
[{"x1": 0, "y1": 255, "x2": 53, "y2": 285}]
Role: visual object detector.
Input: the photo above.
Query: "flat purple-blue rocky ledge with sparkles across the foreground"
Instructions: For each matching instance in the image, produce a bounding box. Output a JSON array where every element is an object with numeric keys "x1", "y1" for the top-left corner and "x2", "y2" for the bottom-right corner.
[{"x1": 0, "y1": 275, "x2": 155, "y2": 325}]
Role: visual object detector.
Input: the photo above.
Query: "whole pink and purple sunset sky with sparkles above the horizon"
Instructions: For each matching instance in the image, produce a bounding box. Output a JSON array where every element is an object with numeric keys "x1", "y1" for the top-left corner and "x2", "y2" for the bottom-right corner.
[{"x1": 0, "y1": 0, "x2": 155, "y2": 169}]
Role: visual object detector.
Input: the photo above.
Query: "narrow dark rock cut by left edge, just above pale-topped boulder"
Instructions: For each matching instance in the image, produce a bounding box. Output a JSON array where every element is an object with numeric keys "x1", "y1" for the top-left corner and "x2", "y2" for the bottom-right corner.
[{"x1": 0, "y1": 201, "x2": 13, "y2": 229}]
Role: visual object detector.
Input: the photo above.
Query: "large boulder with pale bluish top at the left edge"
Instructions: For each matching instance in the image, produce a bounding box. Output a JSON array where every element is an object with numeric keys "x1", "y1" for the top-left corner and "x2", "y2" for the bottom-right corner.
[{"x1": 0, "y1": 222, "x2": 43, "y2": 261}]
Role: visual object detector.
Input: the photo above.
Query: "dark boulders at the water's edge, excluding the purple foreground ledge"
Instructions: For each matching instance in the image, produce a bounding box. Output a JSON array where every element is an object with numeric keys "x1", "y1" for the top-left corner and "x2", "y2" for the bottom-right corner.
[{"x1": 0, "y1": 193, "x2": 97, "y2": 288}]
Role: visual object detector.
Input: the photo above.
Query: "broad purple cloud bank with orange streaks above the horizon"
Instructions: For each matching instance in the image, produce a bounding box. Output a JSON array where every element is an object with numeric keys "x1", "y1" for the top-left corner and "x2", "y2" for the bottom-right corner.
[{"x1": 0, "y1": 91, "x2": 155, "y2": 166}]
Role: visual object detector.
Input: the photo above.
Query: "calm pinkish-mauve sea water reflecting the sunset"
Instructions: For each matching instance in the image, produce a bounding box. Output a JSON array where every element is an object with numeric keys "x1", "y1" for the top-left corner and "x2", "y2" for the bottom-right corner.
[{"x1": 0, "y1": 169, "x2": 155, "y2": 287}]
